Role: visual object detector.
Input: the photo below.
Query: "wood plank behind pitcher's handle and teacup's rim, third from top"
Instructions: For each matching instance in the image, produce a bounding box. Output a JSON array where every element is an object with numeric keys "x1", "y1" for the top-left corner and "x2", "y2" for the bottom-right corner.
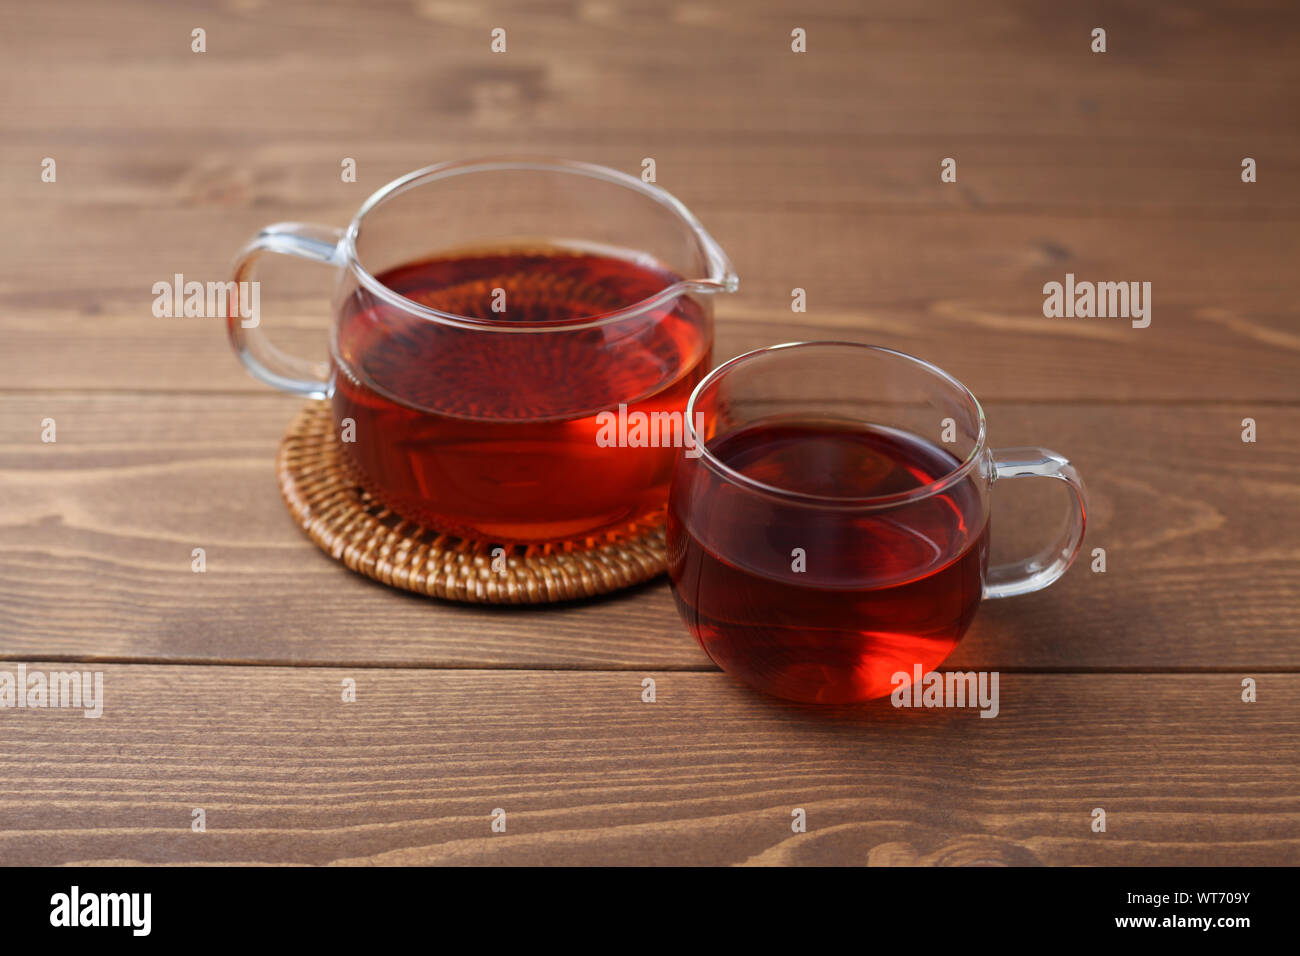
[{"x1": 0, "y1": 207, "x2": 1300, "y2": 402}]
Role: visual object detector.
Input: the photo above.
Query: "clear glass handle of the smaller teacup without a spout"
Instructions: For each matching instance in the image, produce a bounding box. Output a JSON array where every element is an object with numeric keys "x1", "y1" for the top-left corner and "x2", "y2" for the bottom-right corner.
[{"x1": 984, "y1": 447, "x2": 1088, "y2": 597}]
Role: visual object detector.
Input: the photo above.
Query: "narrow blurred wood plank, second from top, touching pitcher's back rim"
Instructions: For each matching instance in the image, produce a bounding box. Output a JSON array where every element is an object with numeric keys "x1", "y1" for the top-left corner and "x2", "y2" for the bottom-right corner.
[{"x1": 0, "y1": 137, "x2": 1300, "y2": 215}]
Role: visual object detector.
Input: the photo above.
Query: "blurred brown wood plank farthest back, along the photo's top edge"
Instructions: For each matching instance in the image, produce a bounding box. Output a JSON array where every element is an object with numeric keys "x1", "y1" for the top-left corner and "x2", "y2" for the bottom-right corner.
[{"x1": 3, "y1": 0, "x2": 1297, "y2": 138}]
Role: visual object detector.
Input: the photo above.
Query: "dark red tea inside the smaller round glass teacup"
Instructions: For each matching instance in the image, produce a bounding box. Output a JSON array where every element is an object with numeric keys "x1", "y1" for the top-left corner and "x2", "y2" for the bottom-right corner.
[{"x1": 668, "y1": 421, "x2": 988, "y2": 702}]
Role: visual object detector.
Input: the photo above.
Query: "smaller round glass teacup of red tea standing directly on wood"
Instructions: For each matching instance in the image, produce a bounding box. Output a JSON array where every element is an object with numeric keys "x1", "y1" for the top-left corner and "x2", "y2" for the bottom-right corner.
[{"x1": 668, "y1": 342, "x2": 1086, "y2": 702}]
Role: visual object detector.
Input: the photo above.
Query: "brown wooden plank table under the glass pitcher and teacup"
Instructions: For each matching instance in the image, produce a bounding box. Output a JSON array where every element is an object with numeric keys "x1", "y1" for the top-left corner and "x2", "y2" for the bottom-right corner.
[{"x1": 0, "y1": 0, "x2": 1300, "y2": 864}]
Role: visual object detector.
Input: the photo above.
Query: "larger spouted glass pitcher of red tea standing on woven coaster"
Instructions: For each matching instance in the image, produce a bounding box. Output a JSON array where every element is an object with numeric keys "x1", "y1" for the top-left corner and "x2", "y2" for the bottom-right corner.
[{"x1": 229, "y1": 159, "x2": 737, "y2": 542}]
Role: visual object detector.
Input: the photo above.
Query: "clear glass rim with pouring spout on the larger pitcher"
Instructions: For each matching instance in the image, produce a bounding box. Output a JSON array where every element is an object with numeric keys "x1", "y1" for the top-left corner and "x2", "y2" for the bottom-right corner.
[{"x1": 339, "y1": 156, "x2": 740, "y2": 333}]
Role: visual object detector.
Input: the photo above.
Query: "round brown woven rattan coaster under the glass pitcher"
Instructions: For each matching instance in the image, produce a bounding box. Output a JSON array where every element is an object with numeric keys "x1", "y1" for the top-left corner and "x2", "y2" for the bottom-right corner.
[{"x1": 277, "y1": 402, "x2": 664, "y2": 604}]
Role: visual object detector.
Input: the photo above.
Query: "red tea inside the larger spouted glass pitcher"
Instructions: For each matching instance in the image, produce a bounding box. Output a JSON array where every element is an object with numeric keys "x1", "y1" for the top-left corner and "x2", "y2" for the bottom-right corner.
[{"x1": 333, "y1": 248, "x2": 711, "y2": 542}]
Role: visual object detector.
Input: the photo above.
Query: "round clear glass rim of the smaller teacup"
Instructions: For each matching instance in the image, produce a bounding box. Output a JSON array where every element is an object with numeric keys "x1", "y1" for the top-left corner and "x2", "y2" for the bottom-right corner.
[{"x1": 683, "y1": 339, "x2": 988, "y2": 509}]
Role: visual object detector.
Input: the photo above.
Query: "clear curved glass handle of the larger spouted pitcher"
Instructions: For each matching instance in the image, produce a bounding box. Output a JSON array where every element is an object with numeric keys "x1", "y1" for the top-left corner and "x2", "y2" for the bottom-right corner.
[{"x1": 226, "y1": 222, "x2": 343, "y2": 398}]
